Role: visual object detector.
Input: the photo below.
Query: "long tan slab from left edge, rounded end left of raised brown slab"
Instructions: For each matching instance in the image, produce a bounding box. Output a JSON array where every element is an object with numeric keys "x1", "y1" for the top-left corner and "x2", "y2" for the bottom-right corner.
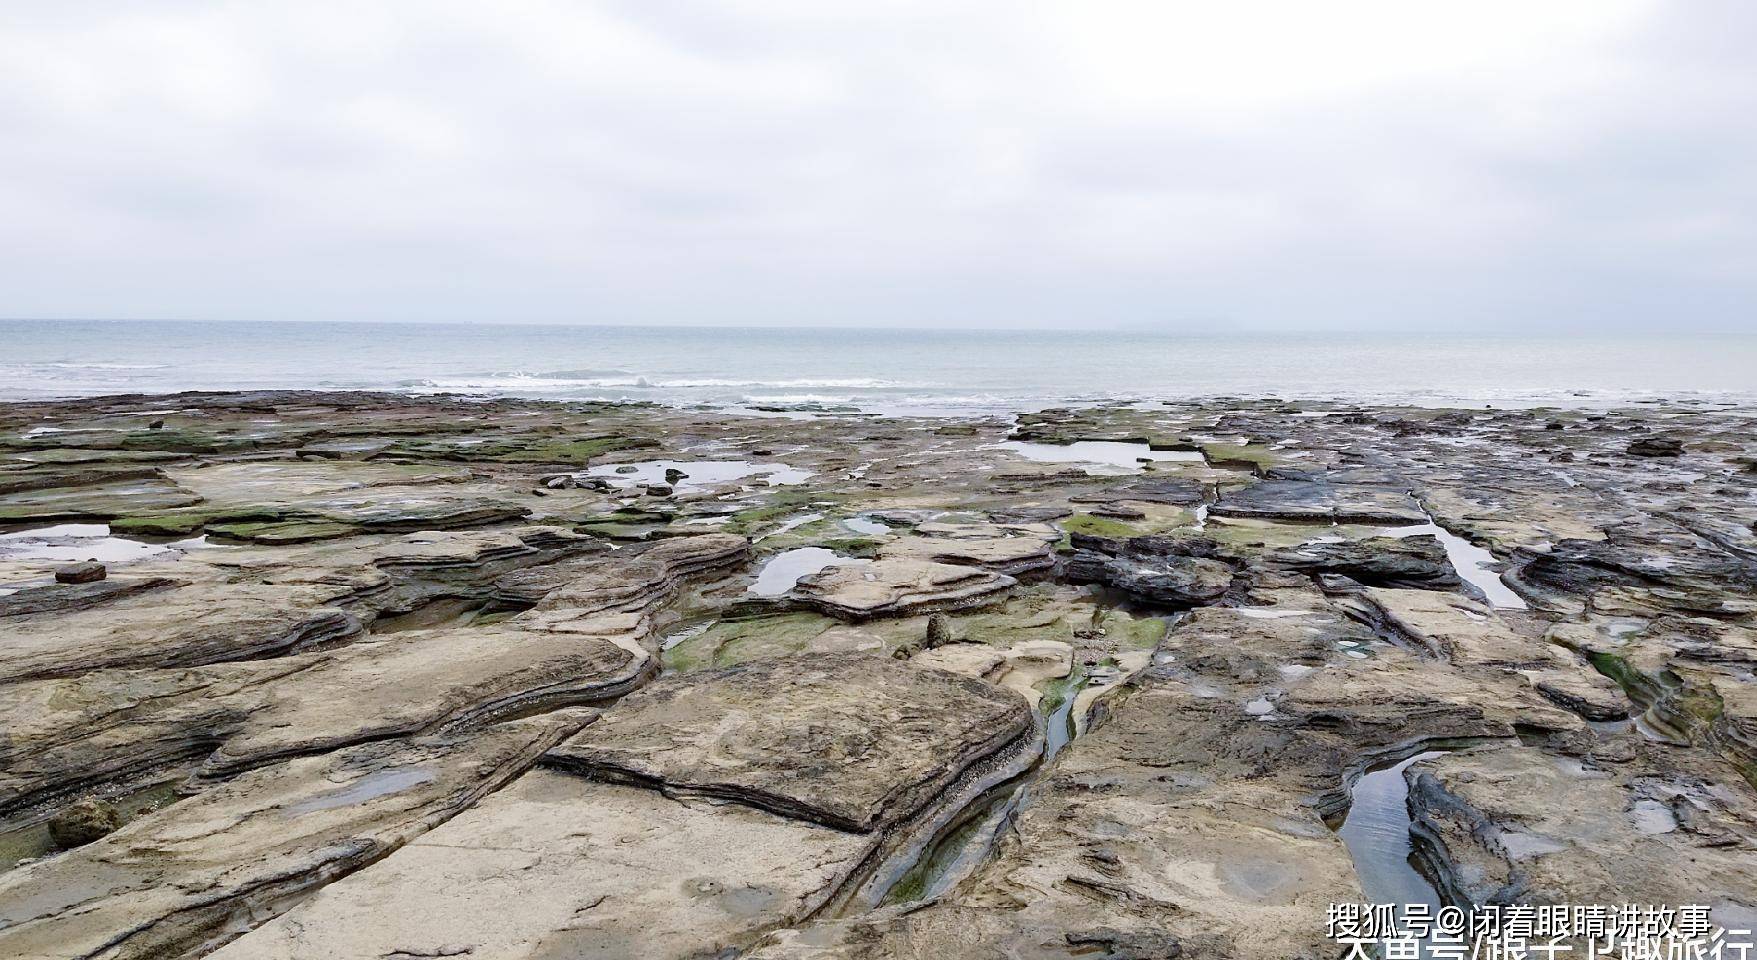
[{"x1": 0, "y1": 626, "x2": 650, "y2": 811}]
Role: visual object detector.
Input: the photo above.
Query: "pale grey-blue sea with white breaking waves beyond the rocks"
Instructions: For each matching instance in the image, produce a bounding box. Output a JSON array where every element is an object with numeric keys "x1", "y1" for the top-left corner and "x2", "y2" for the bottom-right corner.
[{"x1": 0, "y1": 320, "x2": 1757, "y2": 413}]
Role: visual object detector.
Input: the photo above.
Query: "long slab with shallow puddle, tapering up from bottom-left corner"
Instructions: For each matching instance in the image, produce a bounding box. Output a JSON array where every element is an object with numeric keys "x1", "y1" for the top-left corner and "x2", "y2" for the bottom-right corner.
[{"x1": 0, "y1": 712, "x2": 590, "y2": 960}]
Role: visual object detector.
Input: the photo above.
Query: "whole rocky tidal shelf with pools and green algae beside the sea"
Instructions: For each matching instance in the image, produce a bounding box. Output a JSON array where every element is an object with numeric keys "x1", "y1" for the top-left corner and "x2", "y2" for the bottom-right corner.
[{"x1": 0, "y1": 392, "x2": 1757, "y2": 960}]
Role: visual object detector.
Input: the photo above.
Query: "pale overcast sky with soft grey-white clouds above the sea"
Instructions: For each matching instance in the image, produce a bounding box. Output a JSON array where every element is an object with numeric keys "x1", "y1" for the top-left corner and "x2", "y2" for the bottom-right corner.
[{"x1": 0, "y1": 0, "x2": 1757, "y2": 331}]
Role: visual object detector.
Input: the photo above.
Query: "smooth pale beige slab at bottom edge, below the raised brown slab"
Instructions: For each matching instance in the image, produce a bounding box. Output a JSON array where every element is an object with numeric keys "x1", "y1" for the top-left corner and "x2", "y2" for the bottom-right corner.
[{"x1": 211, "y1": 770, "x2": 875, "y2": 960}]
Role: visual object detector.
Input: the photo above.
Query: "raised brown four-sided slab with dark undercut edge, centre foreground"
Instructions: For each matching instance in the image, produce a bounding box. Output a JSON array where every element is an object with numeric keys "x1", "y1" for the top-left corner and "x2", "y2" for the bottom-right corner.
[{"x1": 546, "y1": 654, "x2": 1031, "y2": 830}]
